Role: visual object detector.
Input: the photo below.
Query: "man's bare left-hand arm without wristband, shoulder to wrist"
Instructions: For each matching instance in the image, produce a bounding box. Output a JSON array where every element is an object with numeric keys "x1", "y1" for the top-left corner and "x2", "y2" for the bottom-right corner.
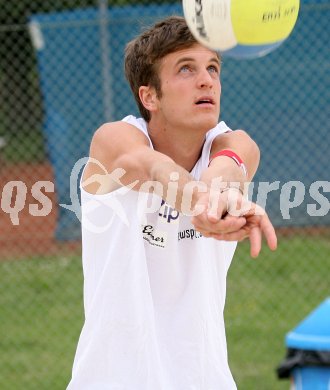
[{"x1": 83, "y1": 122, "x2": 201, "y2": 211}]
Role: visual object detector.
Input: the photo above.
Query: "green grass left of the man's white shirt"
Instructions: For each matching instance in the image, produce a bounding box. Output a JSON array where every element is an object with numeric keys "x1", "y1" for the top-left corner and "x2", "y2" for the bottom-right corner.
[{"x1": 0, "y1": 257, "x2": 83, "y2": 390}]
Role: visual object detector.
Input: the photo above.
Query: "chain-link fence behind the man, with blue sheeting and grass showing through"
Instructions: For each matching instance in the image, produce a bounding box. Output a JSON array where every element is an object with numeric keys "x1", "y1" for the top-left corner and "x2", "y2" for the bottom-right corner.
[{"x1": 0, "y1": 0, "x2": 330, "y2": 390}]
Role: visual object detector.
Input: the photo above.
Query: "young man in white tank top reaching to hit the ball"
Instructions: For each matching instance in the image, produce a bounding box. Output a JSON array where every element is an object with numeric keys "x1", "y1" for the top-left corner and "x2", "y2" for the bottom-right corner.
[{"x1": 68, "y1": 17, "x2": 276, "y2": 390}]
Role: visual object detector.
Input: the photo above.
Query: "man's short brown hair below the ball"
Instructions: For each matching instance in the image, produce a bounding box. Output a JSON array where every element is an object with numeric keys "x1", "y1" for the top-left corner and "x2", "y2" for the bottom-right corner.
[{"x1": 125, "y1": 16, "x2": 197, "y2": 122}]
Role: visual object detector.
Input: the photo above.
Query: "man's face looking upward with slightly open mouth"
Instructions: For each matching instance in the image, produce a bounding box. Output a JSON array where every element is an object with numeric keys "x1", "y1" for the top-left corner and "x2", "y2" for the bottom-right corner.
[{"x1": 153, "y1": 44, "x2": 221, "y2": 131}]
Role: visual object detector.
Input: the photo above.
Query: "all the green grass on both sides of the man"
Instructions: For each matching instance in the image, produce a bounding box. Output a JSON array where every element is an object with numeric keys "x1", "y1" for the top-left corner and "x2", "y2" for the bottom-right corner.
[{"x1": 0, "y1": 236, "x2": 330, "y2": 390}]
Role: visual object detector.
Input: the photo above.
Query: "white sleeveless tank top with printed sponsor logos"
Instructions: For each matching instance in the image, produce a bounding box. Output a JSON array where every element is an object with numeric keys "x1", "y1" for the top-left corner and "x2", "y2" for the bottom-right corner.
[{"x1": 68, "y1": 116, "x2": 236, "y2": 390}]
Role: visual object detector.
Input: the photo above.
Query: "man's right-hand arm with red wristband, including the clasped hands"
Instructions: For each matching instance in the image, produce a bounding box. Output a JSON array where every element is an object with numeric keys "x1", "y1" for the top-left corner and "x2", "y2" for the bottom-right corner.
[{"x1": 192, "y1": 131, "x2": 277, "y2": 257}]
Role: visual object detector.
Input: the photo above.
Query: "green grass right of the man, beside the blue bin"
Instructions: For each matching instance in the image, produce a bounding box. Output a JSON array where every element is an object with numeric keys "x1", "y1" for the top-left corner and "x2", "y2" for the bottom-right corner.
[{"x1": 226, "y1": 236, "x2": 330, "y2": 390}]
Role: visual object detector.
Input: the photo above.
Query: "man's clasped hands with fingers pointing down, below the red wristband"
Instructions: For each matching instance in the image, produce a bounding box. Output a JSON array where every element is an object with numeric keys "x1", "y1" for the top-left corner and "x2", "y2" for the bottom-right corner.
[{"x1": 192, "y1": 188, "x2": 277, "y2": 258}]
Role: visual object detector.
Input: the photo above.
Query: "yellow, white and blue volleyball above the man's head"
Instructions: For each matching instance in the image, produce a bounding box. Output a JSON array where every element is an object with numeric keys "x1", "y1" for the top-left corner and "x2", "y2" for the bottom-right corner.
[{"x1": 182, "y1": 0, "x2": 299, "y2": 58}]
